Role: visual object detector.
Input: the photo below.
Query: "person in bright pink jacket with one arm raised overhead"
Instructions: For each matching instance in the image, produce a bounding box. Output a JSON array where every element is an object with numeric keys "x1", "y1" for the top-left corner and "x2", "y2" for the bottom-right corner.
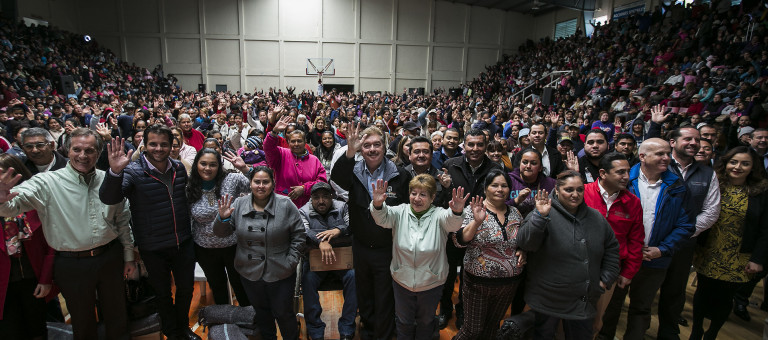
[{"x1": 264, "y1": 116, "x2": 328, "y2": 207}]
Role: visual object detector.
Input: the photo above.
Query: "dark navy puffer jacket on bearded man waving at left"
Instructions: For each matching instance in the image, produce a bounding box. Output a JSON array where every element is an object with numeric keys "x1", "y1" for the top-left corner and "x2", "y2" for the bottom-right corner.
[{"x1": 99, "y1": 154, "x2": 192, "y2": 250}]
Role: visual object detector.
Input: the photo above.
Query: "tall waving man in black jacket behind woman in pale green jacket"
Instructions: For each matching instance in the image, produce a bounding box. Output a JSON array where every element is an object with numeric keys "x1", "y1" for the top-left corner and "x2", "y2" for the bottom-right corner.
[{"x1": 331, "y1": 124, "x2": 411, "y2": 340}]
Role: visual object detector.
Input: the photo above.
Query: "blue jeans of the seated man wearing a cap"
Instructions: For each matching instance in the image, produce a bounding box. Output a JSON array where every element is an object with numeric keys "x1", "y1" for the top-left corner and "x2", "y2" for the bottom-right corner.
[{"x1": 301, "y1": 261, "x2": 357, "y2": 339}]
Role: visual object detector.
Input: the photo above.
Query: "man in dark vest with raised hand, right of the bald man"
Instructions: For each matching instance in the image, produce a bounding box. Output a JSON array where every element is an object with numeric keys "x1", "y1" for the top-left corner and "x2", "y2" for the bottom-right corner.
[{"x1": 648, "y1": 106, "x2": 720, "y2": 340}]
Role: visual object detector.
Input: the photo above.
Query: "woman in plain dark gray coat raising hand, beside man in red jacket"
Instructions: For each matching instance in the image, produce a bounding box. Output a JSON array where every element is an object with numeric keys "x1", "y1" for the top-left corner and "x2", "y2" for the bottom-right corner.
[{"x1": 517, "y1": 170, "x2": 619, "y2": 340}]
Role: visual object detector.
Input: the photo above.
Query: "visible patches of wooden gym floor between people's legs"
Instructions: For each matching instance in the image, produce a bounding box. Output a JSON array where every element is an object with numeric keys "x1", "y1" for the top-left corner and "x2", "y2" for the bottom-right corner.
[{"x1": 177, "y1": 270, "x2": 768, "y2": 340}]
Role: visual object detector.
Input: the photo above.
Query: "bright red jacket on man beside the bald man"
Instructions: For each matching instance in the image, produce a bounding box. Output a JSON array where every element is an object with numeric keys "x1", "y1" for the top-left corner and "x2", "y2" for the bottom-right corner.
[{"x1": 584, "y1": 181, "x2": 645, "y2": 280}]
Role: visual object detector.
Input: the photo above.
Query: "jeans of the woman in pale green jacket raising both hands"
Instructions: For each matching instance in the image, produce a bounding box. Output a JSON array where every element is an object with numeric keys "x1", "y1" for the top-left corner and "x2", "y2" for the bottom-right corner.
[{"x1": 392, "y1": 281, "x2": 443, "y2": 340}]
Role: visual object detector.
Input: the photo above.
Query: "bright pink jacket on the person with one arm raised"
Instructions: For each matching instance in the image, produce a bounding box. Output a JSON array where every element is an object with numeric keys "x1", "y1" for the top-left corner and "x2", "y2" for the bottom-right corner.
[{"x1": 264, "y1": 133, "x2": 328, "y2": 208}]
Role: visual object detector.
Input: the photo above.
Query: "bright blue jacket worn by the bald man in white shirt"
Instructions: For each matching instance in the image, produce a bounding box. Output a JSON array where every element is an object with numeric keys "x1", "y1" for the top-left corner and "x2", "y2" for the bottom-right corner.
[{"x1": 627, "y1": 163, "x2": 696, "y2": 268}]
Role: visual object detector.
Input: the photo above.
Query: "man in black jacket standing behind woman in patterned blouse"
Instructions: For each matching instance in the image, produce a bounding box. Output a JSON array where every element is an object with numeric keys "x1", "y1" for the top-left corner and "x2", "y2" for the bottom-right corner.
[{"x1": 438, "y1": 129, "x2": 500, "y2": 329}]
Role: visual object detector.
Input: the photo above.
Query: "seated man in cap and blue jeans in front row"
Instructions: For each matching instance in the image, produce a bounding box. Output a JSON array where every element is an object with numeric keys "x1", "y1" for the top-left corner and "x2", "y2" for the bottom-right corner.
[{"x1": 299, "y1": 182, "x2": 357, "y2": 340}]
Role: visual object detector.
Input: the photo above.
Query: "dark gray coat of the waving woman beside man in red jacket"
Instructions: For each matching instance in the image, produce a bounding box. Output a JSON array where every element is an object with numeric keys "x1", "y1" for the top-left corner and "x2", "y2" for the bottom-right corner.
[{"x1": 517, "y1": 193, "x2": 619, "y2": 320}]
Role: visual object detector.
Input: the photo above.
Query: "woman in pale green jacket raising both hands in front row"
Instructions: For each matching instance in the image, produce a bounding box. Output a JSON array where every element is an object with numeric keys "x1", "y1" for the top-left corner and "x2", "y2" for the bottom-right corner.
[{"x1": 370, "y1": 174, "x2": 469, "y2": 340}]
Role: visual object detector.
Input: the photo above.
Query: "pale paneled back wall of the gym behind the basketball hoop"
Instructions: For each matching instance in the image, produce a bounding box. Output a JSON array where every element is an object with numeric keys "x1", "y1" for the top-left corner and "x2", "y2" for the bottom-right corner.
[{"x1": 18, "y1": 0, "x2": 536, "y2": 92}]
